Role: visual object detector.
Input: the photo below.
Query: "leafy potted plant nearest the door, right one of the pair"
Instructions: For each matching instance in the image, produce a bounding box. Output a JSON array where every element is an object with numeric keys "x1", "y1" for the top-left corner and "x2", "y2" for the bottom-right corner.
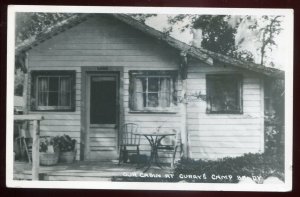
[{"x1": 55, "y1": 135, "x2": 76, "y2": 163}]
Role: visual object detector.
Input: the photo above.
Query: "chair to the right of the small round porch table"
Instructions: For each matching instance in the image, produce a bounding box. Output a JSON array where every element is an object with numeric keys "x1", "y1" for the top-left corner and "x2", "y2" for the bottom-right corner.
[{"x1": 157, "y1": 129, "x2": 183, "y2": 168}]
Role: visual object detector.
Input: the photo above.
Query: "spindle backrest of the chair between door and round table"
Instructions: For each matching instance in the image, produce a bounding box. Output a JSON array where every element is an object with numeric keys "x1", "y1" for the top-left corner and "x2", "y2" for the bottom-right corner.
[{"x1": 121, "y1": 123, "x2": 140, "y2": 145}]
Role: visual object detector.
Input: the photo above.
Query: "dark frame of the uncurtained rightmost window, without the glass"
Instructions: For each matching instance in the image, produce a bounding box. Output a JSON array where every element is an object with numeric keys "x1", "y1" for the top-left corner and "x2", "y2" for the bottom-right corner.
[{"x1": 206, "y1": 73, "x2": 243, "y2": 114}]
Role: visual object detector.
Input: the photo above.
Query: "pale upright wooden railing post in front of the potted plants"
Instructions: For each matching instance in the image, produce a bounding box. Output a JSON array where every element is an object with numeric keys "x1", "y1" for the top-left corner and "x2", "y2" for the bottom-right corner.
[{"x1": 32, "y1": 120, "x2": 40, "y2": 180}]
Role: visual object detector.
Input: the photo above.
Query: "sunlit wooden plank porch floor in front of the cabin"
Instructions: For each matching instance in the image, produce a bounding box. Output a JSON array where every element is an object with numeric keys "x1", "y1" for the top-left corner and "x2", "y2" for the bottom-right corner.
[{"x1": 14, "y1": 161, "x2": 173, "y2": 181}]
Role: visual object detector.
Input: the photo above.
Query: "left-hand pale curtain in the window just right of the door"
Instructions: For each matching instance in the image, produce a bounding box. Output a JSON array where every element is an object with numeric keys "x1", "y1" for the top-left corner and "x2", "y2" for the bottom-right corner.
[{"x1": 132, "y1": 78, "x2": 143, "y2": 110}]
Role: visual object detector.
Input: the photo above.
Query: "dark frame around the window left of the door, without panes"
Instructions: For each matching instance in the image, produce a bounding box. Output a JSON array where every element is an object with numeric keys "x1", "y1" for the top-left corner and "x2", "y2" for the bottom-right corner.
[{"x1": 30, "y1": 70, "x2": 76, "y2": 112}]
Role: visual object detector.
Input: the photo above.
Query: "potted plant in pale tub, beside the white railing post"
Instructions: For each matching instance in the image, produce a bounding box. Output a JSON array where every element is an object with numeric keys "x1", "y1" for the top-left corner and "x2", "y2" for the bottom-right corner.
[{"x1": 39, "y1": 137, "x2": 59, "y2": 166}]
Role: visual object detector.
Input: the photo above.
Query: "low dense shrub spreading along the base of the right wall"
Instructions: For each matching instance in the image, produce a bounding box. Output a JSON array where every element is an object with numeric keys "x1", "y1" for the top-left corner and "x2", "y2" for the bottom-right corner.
[{"x1": 174, "y1": 153, "x2": 284, "y2": 183}]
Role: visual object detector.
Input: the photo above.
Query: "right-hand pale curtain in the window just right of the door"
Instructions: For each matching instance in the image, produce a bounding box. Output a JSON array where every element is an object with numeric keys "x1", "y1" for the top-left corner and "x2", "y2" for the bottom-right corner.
[{"x1": 159, "y1": 78, "x2": 171, "y2": 107}]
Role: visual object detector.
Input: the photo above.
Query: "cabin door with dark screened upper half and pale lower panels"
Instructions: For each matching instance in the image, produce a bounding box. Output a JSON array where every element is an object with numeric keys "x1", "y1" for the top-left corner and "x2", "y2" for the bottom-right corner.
[{"x1": 85, "y1": 73, "x2": 119, "y2": 160}]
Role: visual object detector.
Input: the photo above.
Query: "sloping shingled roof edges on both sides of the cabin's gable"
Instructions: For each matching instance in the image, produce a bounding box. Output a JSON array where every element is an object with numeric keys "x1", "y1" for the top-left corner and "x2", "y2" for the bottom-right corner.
[{"x1": 15, "y1": 14, "x2": 284, "y2": 78}]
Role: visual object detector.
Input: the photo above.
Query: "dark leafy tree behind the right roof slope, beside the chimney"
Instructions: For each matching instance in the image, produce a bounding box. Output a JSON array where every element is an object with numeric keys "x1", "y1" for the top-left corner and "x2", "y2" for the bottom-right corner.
[{"x1": 169, "y1": 15, "x2": 254, "y2": 62}]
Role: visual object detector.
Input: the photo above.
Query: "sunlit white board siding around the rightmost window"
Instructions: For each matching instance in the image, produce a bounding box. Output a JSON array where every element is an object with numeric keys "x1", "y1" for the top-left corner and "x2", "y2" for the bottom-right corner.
[{"x1": 187, "y1": 63, "x2": 264, "y2": 159}]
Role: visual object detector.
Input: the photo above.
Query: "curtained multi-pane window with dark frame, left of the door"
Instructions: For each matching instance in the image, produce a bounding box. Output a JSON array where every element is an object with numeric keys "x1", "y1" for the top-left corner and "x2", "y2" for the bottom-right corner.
[{"x1": 31, "y1": 71, "x2": 75, "y2": 111}]
